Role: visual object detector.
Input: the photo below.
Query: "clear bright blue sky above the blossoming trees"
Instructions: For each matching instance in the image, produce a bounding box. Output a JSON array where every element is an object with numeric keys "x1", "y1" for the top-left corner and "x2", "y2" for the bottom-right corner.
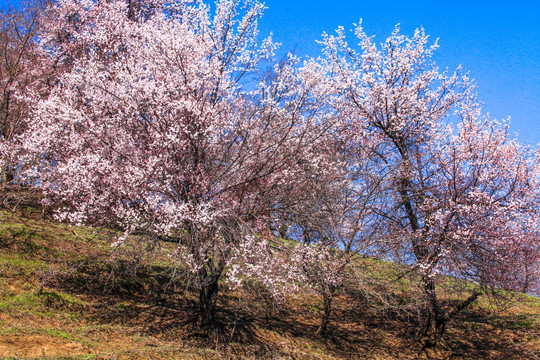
[{"x1": 0, "y1": 0, "x2": 540, "y2": 145}]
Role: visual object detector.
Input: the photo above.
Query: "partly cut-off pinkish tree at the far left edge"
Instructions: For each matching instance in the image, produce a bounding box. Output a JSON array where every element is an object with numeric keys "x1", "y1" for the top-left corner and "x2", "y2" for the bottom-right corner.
[{"x1": 0, "y1": 1, "x2": 54, "y2": 208}]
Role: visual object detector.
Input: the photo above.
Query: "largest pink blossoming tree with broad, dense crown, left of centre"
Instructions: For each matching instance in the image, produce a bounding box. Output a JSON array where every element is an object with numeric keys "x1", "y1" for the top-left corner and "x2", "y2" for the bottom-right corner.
[{"x1": 25, "y1": 0, "x2": 338, "y2": 325}]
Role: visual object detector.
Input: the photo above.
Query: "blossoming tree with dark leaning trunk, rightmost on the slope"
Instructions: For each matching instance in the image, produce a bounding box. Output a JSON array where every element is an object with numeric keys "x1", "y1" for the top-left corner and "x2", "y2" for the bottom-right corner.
[{"x1": 321, "y1": 26, "x2": 540, "y2": 344}]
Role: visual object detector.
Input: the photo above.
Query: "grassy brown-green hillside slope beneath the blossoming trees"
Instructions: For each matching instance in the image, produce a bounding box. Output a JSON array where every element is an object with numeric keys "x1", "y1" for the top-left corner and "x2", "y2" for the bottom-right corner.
[{"x1": 0, "y1": 212, "x2": 540, "y2": 359}]
